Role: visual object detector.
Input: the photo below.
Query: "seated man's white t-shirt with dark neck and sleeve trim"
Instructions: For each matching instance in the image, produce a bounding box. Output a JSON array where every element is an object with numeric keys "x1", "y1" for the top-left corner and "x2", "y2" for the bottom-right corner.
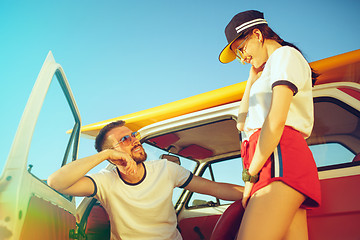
[{"x1": 90, "y1": 159, "x2": 193, "y2": 240}]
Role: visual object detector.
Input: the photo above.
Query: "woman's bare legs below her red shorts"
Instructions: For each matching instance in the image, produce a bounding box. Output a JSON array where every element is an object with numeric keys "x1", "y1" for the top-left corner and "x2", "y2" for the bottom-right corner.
[{"x1": 237, "y1": 181, "x2": 307, "y2": 240}]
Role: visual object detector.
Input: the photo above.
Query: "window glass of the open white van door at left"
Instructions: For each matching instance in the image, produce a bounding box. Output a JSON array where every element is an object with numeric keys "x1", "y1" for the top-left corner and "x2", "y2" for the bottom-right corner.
[{"x1": 28, "y1": 76, "x2": 75, "y2": 182}]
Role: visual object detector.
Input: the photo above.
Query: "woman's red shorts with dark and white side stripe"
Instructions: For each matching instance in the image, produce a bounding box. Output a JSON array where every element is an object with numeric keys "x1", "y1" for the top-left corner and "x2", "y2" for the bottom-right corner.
[{"x1": 241, "y1": 126, "x2": 321, "y2": 208}]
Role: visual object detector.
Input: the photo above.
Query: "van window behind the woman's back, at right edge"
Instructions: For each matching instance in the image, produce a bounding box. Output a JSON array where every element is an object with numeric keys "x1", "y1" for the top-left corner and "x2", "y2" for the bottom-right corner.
[{"x1": 307, "y1": 97, "x2": 360, "y2": 167}]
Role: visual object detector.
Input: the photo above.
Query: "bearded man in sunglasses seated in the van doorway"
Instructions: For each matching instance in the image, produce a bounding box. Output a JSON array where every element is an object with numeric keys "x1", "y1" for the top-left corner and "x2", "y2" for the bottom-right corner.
[{"x1": 48, "y1": 121, "x2": 243, "y2": 240}]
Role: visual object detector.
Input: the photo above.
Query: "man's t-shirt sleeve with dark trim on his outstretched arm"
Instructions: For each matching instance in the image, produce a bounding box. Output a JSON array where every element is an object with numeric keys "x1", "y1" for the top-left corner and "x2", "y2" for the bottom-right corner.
[{"x1": 167, "y1": 161, "x2": 193, "y2": 188}]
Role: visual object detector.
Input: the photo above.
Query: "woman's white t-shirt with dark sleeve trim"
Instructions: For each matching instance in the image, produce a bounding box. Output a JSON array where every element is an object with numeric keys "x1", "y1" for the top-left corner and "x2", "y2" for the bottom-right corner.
[{"x1": 245, "y1": 46, "x2": 314, "y2": 138}]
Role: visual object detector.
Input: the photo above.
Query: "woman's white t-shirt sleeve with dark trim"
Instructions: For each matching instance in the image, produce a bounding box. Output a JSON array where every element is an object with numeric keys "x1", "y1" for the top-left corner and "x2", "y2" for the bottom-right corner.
[{"x1": 270, "y1": 47, "x2": 309, "y2": 95}]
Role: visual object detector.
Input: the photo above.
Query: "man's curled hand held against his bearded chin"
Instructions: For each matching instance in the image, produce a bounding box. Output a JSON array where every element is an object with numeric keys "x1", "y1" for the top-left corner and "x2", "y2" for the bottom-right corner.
[{"x1": 108, "y1": 149, "x2": 137, "y2": 175}]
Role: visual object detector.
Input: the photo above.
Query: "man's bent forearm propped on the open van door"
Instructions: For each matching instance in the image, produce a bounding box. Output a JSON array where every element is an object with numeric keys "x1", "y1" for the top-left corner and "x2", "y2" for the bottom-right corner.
[{"x1": 48, "y1": 150, "x2": 108, "y2": 191}]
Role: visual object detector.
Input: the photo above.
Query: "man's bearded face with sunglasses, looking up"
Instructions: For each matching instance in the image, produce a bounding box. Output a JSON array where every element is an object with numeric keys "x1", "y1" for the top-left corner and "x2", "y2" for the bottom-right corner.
[{"x1": 106, "y1": 127, "x2": 147, "y2": 163}]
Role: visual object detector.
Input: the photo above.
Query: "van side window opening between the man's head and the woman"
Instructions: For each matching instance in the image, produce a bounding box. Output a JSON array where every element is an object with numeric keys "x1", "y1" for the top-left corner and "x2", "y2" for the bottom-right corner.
[{"x1": 144, "y1": 115, "x2": 242, "y2": 207}]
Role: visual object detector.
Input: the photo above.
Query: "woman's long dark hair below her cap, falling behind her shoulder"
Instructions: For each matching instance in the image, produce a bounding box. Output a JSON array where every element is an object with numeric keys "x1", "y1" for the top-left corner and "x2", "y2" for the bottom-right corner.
[{"x1": 242, "y1": 24, "x2": 319, "y2": 86}]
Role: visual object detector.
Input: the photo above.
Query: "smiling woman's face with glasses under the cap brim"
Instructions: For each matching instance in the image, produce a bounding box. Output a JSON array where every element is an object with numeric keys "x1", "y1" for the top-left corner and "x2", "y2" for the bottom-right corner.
[{"x1": 231, "y1": 29, "x2": 266, "y2": 68}]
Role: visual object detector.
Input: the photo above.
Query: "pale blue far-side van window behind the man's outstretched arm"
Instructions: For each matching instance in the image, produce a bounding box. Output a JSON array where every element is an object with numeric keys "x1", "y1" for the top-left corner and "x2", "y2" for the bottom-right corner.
[{"x1": 188, "y1": 158, "x2": 244, "y2": 207}]
